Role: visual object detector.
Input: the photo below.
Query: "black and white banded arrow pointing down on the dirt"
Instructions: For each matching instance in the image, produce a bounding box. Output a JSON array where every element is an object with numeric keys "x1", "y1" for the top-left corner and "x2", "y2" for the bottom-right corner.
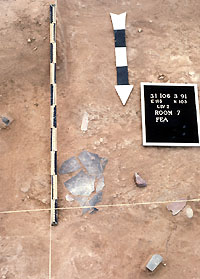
[{"x1": 110, "y1": 13, "x2": 133, "y2": 106}]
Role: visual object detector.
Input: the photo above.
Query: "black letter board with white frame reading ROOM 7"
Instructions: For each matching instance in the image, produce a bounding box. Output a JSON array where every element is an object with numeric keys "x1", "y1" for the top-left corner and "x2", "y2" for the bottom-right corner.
[{"x1": 141, "y1": 83, "x2": 200, "y2": 146}]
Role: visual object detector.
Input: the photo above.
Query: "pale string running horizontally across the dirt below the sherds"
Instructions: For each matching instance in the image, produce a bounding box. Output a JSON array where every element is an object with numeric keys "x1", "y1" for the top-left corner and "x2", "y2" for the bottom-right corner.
[{"x1": 0, "y1": 198, "x2": 200, "y2": 214}]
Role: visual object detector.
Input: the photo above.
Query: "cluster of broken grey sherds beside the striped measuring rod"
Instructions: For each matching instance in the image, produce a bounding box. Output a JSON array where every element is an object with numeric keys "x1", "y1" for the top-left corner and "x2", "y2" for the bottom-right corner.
[{"x1": 59, "y1": 150, "x2": 108, "y2": 213}]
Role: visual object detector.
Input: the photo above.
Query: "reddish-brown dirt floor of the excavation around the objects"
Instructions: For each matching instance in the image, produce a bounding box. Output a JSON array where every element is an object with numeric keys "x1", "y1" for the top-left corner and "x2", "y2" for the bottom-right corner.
[{"x1": 0, "y1": 0, "x2": 200, "y2": 279}]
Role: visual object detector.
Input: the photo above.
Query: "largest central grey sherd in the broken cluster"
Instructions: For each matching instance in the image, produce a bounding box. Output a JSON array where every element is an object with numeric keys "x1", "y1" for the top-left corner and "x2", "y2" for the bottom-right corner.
[{"x1": 64, "y1": 170, "x2": 95, "y2": 196}]
